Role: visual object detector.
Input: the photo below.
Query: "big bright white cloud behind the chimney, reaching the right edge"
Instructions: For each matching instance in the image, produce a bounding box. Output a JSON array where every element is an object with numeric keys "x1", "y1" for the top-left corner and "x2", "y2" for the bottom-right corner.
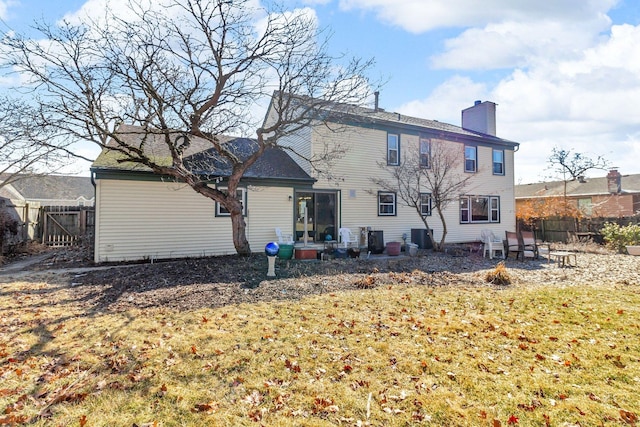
[{"x1": 400, "y1": 19, "x2": 640, "y2": 183}]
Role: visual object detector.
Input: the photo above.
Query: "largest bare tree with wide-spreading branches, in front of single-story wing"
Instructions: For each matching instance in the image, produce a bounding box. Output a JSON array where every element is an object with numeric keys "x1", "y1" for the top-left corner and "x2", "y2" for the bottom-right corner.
[{"x1": 3, "y1": 0, "x2": 372, "y2": 255}]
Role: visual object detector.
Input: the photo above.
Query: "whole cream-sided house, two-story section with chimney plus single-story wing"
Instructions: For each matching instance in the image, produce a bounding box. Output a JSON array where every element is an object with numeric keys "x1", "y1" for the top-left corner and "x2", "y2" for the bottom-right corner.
[{"x1": 91, "y1": 99, "x2": 518, "y2": 262}]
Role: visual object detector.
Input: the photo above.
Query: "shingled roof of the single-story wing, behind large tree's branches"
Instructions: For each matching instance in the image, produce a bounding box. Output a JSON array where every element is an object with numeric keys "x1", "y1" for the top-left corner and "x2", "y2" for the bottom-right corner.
[{"x1": 91, "y1": 125, "x2": 314, "y2": 182}]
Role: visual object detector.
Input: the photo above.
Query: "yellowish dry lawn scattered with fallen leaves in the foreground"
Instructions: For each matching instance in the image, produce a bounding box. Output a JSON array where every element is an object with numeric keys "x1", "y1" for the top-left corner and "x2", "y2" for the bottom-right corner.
[{"x1": 0, "y1": 273, "x2": 640, "y2": 426}]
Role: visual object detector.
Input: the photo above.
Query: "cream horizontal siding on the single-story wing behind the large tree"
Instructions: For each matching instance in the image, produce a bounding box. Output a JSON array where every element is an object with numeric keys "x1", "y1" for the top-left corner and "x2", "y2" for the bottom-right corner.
[{"x1": 95, "y1": 179, "x2": 293, "y2": 262}]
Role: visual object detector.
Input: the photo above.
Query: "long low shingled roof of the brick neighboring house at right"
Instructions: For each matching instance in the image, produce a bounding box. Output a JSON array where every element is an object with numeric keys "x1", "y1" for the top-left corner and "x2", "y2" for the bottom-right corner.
[{"x1": 515, "y1": 174, "x2": 640, "y2": 199}]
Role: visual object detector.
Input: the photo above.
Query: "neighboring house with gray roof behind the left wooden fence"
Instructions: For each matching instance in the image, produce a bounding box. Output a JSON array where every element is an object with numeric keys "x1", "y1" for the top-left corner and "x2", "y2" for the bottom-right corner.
[{"x1": 0, "y1": 174, "x2": 95, "y2": 206}]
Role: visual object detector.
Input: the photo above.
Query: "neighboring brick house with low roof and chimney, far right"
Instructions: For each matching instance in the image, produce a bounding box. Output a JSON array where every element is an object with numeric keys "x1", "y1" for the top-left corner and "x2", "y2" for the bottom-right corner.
[{"x1": 515, "y1": 169, "x2": 640, "y2": 218}]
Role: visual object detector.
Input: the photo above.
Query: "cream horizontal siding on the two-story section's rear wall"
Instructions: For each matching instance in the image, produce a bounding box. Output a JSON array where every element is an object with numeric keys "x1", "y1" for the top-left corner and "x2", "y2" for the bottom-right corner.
[{"x1": 313, "y1": 128, "x2": 515, "y2": 243}]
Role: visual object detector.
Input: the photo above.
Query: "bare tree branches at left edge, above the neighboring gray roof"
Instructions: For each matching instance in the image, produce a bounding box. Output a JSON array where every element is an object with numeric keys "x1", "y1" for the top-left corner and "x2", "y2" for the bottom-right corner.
[{"x1": 0, "y1": 97, "x2": 81, "y2": 188}]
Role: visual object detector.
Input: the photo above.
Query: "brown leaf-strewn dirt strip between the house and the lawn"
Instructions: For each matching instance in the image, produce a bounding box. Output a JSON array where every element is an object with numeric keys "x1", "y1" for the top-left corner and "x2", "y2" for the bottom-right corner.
[{"x1": 2, "y1": 249, "x2": 640, "y2": 311}]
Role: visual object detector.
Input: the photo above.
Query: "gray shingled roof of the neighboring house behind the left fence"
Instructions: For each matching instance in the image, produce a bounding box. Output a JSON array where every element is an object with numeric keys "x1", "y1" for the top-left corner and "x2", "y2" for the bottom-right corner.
[{"x1": 0, "y1": 175, "x2": 94, "y2": 200}]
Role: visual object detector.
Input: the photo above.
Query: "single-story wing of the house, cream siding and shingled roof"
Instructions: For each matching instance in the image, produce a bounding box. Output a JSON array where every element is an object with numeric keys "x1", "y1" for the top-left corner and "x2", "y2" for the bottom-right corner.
[{"x1": 91, "y1": 126, "x2": 314, "y2": 262}]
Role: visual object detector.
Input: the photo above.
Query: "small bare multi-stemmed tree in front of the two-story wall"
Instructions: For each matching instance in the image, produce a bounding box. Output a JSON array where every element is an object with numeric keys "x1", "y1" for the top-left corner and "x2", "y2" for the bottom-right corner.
[{"x1": 370, "y1": 139, "x2": 472, "y2": 251}]
